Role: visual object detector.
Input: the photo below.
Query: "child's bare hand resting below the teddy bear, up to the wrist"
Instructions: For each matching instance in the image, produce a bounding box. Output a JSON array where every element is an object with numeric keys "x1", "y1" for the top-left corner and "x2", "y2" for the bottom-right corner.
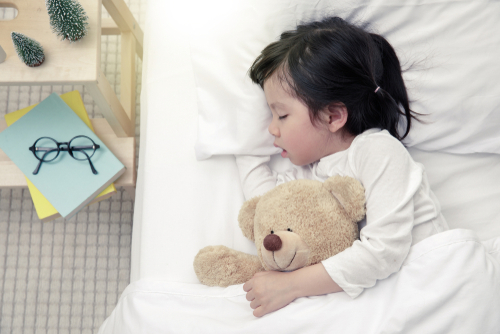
[{"x1": 243, "y1": 271, "x2": 297, "y2": 317}]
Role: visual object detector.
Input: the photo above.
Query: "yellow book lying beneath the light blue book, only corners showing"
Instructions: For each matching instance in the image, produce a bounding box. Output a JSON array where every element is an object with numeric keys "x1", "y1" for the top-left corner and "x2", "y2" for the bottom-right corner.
[{"x1": 5, "y1": 90, "x2": 116, "y2": 222}]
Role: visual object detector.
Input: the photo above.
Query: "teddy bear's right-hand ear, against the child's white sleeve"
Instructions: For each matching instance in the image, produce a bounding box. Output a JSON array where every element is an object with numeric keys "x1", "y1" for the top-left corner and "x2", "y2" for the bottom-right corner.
[{"x1": 323, "y1": 175, "x2": 366, "y2": 222}]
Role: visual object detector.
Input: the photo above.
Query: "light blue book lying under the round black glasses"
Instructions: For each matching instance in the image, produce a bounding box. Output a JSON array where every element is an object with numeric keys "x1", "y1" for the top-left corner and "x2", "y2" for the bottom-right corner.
[{"x1": 0, "y1": 93, "x2": 125, "y2": 218}]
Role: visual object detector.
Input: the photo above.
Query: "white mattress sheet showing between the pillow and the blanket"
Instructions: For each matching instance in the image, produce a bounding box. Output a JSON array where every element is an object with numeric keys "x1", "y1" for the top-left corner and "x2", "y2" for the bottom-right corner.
[{"x1": 131, "y1": 7, "x2": 500, "y2": 283}]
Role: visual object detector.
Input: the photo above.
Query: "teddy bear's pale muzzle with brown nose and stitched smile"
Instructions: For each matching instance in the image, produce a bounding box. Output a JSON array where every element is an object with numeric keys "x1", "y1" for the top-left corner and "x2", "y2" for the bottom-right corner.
[{"x1": 261, "y1": 231, "x2": 310, "y2": 271}]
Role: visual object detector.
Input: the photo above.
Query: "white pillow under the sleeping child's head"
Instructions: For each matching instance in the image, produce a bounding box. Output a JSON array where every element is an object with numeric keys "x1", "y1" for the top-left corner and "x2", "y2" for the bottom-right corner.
[{"x1": 190, "y1": 0, "x2": 500, "y2": 160}]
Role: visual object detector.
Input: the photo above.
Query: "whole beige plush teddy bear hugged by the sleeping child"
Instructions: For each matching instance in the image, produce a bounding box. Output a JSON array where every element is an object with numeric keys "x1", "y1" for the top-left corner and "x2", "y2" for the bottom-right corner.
[{"x1": 193, "y1": 175, "x2": 366, "y2": 287}]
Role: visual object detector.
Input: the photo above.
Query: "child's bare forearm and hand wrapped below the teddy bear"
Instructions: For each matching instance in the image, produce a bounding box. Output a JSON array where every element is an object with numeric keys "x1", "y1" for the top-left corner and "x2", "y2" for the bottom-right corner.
[{"x1": 243, "y1": 263, "x2": 342, "y2": 317}]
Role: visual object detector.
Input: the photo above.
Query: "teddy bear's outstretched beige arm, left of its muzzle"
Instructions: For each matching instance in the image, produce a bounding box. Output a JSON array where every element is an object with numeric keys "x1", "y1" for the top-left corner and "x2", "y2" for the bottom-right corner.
[{"x1": 193, "y1": 246, "x2": 264, "y2": 287}]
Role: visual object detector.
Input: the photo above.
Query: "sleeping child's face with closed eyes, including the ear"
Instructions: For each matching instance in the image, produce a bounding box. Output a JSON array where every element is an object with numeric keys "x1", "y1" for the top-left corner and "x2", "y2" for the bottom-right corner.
[{"x1": 264, "y1": 75, "x2": 338, "y2": 166}]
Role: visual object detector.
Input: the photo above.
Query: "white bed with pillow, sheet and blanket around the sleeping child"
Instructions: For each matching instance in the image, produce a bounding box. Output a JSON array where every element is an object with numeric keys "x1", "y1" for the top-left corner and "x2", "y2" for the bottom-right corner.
[{"x1": 99, "y1": 0, "x2": 500, "y2": 334}]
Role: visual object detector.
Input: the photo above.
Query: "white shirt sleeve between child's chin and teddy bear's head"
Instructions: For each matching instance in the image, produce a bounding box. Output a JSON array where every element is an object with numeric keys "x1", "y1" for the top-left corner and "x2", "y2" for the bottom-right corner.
[{"x1": 235, "y1": 155, "x2": 311, "y2": 200}]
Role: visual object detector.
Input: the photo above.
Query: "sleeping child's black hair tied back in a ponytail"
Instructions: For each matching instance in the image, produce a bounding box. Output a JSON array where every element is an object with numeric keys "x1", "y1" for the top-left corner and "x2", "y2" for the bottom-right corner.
[{"x1": 249, "y1": 17, "x2": 418, "y2": 140}]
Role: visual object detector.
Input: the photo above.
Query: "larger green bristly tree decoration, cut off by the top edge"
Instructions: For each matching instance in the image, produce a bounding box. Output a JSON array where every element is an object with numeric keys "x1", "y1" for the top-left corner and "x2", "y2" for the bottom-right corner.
[{"x1": 45, "y1": 0, "x2": 89, "y2": 42}]
